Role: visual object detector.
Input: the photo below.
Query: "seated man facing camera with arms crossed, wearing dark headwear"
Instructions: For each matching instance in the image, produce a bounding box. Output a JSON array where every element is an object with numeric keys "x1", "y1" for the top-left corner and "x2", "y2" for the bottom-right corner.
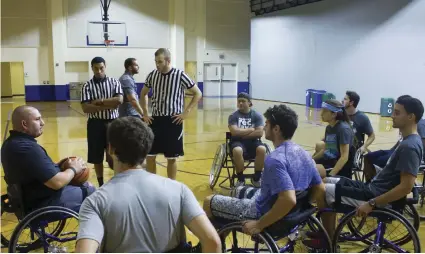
[{"x1": 229, "y1": 93, "x2": 266, "y2": 187}]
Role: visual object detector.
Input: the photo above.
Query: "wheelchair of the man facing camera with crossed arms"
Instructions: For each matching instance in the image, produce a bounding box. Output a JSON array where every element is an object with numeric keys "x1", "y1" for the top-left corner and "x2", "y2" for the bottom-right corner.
[{"x1": 210, "y1": 132, "x2": 272, "y2": 190}]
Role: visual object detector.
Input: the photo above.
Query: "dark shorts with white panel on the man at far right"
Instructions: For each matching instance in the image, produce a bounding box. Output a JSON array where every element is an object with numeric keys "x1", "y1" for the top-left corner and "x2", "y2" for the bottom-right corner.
[{"x1": 325, "y1": 177, "x2": 376, "y2": 207}]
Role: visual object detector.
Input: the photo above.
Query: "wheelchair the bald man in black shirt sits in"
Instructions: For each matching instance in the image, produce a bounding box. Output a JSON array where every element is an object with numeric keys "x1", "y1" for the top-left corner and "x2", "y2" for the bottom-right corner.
[{"x1": 1, "y1": 184, "x2": 78, "y2": 253}]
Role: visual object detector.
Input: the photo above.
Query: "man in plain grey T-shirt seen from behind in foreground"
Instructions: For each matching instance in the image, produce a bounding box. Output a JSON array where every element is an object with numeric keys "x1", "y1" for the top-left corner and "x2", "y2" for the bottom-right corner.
[{"x1": 76, "y1": 116, "x2": 221, "y2": 253}]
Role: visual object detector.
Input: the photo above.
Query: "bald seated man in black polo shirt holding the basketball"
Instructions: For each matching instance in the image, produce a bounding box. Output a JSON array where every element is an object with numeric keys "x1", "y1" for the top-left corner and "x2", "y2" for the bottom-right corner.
[{"x1": 1, "y1": 106, "x2": 95, "y2": 213}]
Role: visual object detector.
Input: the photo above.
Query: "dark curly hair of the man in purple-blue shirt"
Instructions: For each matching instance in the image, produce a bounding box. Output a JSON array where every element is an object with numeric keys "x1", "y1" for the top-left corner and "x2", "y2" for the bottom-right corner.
[{"x1": 264, "y1": 104, "x2": 298, "y2": 139}]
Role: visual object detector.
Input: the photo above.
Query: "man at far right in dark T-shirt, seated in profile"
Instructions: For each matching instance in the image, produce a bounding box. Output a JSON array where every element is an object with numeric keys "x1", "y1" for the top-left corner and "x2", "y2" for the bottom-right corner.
[{"x1": 317, "y1": 97, "x2": 424, "y2": 238}]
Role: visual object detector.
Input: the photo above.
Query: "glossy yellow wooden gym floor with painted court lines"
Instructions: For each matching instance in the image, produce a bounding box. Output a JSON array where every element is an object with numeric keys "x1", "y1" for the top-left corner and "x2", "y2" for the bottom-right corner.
[{"x1": 1, "y1": 98, "x2": 425, "y2": 252}]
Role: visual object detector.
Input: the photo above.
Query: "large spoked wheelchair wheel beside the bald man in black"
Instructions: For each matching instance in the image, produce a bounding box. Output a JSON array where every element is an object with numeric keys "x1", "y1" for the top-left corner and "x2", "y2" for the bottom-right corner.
[{"x1": 9, "y1": 206, "x2": 78, "y2": 253}]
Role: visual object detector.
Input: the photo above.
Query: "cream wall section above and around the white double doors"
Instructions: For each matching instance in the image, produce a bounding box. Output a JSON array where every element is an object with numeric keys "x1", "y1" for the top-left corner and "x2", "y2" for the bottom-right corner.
[{"x1": 185, "y1": 0, "x2": 251, "y2": 82}]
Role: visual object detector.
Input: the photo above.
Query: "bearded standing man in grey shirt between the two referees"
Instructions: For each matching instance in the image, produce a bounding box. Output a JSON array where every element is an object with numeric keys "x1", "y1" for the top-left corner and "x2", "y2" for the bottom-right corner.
[{"x1": 119, "y1": 58, "x2": 143, "y2": 118}]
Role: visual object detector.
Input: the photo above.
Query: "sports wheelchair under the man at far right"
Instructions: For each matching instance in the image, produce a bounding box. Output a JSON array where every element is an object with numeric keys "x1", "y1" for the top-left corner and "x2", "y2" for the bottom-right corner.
[{"x1": 316, "y1": 188, "x2": 421, "y2": 253}]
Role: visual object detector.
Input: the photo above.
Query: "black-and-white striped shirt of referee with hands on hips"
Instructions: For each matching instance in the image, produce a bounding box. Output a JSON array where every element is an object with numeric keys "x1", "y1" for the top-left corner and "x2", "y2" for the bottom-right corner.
[{"x1": 145, "y1": 68, "x2": 195, "y2": 116}]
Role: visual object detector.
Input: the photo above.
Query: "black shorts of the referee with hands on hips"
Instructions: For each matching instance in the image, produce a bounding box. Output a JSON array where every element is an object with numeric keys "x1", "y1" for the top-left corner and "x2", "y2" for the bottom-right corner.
[{"x1": 148, "y1": 116, "x2": 184, "y2": 158}]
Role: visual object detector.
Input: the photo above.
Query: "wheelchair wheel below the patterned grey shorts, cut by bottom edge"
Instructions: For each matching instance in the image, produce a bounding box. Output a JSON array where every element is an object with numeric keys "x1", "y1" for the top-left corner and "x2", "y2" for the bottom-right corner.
[{"x1": 218, "y1": 222, "x2": 278, "y2": 253}]
